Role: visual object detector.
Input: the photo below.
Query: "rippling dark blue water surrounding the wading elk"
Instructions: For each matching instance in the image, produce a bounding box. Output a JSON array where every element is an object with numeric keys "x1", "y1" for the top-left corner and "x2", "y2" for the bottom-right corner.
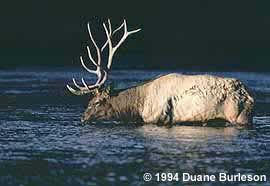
[{"x1": 0, "y1": 70, "x2": 270, "y2": 185}]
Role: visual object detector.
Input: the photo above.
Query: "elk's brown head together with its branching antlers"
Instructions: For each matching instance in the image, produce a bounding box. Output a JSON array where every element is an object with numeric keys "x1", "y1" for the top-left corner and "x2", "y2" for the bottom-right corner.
[{"x1": 67, "y1": 20, "x2": 141, "y2": 122}]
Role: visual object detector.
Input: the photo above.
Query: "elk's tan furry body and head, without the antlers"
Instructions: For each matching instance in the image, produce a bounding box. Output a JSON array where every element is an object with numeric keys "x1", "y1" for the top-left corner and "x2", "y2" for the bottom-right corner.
[{"x1": 82, "y1": 74, "x2": 254, "y2": 125}]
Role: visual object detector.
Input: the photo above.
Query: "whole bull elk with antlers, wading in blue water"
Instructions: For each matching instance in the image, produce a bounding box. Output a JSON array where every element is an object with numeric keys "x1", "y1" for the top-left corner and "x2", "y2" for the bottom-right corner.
[{"x1": 67, "y1": 20, "x2": 254, "y2": 125}]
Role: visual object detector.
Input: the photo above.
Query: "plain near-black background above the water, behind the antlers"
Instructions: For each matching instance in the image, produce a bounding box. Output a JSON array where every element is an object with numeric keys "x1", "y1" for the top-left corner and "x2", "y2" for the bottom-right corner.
[{"x1": 0, "y1": 0, "x2": 270, "y2": 71}]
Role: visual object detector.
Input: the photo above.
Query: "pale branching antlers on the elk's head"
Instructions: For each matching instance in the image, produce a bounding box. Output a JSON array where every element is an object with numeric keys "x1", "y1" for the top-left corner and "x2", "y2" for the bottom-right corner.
[{"x1": 67, "y1": 19, "x2": 141, "y2": 95}]
